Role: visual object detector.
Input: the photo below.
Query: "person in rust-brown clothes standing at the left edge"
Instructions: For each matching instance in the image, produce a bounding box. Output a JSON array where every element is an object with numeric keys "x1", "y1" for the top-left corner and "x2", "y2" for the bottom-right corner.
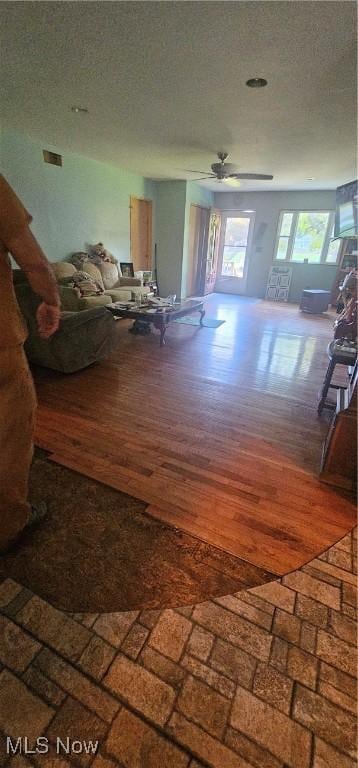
[{"x1": 0, "y1": 174, "x2": 60, "y2": 552}]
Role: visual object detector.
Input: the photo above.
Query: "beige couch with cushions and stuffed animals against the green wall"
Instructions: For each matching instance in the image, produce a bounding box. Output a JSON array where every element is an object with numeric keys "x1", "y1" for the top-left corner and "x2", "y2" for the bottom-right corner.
[{"x1": 51, "y1": 261, "x2": 150, "y2": 312}]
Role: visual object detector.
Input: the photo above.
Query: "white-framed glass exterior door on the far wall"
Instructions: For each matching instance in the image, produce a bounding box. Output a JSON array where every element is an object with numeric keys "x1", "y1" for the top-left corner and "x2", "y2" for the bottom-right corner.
[{"x1": 215, "y1": 211, "x2": 255, "y2": 294}]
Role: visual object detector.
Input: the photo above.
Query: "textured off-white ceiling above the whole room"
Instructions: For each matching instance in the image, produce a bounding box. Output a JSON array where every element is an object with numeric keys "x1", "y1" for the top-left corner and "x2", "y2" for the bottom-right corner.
[{"x1": 0, "y1": 0, "x2": 356, "y2": 191}]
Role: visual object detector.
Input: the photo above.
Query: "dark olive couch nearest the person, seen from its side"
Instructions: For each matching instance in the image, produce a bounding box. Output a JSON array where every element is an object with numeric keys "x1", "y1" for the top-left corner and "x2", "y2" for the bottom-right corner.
[{"x1": 14, "y1": 280, "x2": 118, "y2": 373}]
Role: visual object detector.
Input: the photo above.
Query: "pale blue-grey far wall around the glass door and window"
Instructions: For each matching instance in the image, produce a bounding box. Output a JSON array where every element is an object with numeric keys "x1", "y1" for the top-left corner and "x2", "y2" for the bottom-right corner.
[{"x1": 214, "y1": 190, "x2": 337, "y2": 302}]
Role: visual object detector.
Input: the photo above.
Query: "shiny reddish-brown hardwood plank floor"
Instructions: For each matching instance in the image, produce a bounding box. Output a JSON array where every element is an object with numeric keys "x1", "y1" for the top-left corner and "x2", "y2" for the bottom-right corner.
[{"x1": 35, "y1": 294, "x2": 355, "y2": 574}]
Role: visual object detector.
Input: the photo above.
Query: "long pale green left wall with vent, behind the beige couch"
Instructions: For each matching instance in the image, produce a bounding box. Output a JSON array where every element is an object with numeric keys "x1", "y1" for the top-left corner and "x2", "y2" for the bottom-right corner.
[{"x1": 1, "y1": 130, "x2": 155, "y2": 261}]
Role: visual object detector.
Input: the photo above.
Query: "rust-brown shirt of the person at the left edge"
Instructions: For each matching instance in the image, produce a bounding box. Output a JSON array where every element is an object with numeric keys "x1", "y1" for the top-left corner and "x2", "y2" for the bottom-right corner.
[{"x1": 0, "y1": 174, "x2": 32, "y2": 349}]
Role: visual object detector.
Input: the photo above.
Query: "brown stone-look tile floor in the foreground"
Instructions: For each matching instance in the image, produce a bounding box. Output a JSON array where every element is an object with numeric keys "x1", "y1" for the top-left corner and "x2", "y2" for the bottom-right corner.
[{"x1": 0, "y1": 534, "x2": 357, "y2": 768}]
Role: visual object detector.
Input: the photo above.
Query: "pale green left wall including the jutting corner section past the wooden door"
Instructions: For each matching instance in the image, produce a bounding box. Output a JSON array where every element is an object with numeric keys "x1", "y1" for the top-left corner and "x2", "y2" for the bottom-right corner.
[{"x1": 1, "y1": 130, "x2": 213, "y2": 296}]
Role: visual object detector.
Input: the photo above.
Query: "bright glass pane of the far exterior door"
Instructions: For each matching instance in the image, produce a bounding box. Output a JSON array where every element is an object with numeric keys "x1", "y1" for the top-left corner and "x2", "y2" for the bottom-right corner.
[{"x1": 221, "y1": 216, "x2": 250, "y2": 277}]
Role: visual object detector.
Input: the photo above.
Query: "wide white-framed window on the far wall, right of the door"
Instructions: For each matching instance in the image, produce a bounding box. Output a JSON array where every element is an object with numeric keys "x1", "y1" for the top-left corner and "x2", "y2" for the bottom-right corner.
[{"x1": 275, "y1": 211, "x2": 340, "y2": 264}]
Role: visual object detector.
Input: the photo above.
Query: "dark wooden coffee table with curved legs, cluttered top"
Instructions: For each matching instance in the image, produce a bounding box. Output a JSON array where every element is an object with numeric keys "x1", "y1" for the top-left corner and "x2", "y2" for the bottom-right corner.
[{"x1": 107, "y1": 299, "x2": 205, "y2": 347}]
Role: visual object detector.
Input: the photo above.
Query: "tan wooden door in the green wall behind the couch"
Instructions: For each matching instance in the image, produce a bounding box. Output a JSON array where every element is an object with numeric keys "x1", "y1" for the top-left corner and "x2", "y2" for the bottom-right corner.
[{"x1": 130, "y1": 197, "x2": 152, "y2": 271}]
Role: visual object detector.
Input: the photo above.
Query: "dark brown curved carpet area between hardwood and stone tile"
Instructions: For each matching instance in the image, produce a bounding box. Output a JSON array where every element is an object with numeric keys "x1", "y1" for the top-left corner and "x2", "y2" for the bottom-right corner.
[{"x1": 0, "y1": 457, "x2": 277, "y2": 613}]
